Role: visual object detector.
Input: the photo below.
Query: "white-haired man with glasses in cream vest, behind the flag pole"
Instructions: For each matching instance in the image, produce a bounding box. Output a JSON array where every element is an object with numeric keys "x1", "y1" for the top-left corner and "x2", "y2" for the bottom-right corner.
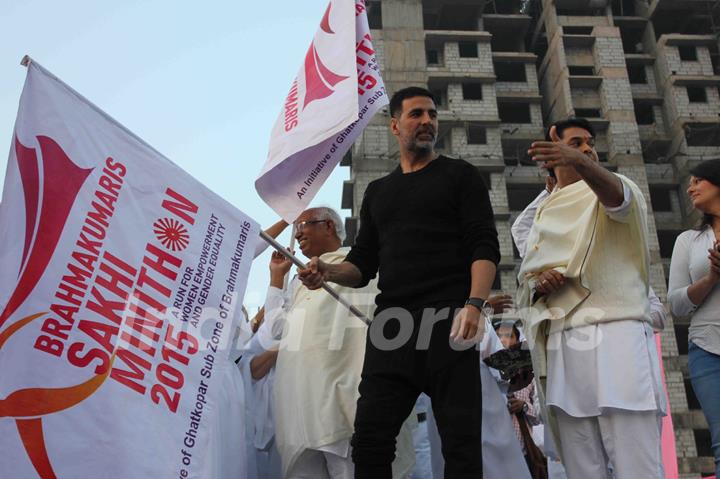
[{"x1": 258, "y1": 208, "x2": 414, "y2": 479}]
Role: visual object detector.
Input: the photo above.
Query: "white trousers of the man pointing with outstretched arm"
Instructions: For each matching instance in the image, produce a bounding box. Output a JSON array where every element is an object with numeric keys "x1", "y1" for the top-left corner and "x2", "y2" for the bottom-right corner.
[{"x1": 554, "y1": 408, "x2": 664, "y2": 479}]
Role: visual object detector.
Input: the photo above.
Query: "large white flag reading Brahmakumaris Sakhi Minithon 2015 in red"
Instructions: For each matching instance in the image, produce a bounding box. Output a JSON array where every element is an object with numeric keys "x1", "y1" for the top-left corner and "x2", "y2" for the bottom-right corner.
[{"x1": 0, "y1": 62, "x2": 259, "y2": 479}]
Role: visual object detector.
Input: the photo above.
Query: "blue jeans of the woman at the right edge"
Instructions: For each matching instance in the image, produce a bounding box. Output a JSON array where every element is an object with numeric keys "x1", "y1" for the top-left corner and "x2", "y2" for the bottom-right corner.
[{"x1": 688, "y1": 341, "x2": 720, "y2": 478}]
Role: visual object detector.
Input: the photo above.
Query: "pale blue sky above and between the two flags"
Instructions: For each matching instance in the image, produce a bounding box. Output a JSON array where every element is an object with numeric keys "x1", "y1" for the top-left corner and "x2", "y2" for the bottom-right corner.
[{"x1": 0, "y1": 0, "x2": 350, "y2": 312}]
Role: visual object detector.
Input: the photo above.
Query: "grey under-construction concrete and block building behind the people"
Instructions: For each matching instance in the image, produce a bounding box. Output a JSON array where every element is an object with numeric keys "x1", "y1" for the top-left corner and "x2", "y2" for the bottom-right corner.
[{"x1": 342, "y1": 0, "x2": 720, "y2": 478}]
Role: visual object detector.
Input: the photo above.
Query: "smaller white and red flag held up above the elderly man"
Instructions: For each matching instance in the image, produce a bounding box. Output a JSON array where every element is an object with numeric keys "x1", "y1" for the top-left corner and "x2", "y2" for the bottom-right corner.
[{"x1": 255, "y1": 0, "x2": 388, "y2": 222}]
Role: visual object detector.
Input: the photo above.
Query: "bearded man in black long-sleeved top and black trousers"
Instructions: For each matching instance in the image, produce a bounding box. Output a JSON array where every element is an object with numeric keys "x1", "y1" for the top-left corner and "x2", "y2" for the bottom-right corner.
[{"x1": 299, "y1": 87, "x2": 500, "y2": 479}]
